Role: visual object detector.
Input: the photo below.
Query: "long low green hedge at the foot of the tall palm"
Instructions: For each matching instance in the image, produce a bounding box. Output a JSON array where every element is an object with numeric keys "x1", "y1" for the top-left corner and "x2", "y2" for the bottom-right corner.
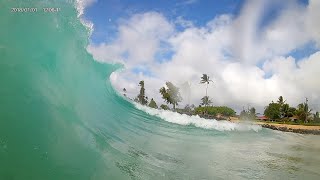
[{"x1": 194, "y1": 106, "x2": 236, "y2": 116}]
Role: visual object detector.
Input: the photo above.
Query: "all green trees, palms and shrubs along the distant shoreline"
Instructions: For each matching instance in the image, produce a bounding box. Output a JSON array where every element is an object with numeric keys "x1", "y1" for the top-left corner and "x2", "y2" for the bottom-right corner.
[{"x1": 131, "y1": 78, "x2": 320, "y2": 125}]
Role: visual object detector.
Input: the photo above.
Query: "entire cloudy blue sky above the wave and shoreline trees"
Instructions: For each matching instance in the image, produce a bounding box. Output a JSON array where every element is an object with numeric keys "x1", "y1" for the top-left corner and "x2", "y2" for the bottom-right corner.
[{"x1": 79, "y1": 0, "x2": 320, "y2": 113}]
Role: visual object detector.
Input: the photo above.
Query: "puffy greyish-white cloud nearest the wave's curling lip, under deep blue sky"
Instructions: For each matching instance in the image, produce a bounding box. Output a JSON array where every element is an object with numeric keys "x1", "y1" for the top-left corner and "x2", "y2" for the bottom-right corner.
[{"x1": 88, "y1": 12, "x2": 174, "y2": 68}]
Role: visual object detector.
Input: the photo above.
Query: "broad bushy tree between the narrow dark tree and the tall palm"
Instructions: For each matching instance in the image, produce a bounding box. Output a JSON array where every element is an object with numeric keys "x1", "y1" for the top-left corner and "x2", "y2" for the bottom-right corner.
[{"x1": 159, "y1": 82, "x2": 182, "y2": 110}]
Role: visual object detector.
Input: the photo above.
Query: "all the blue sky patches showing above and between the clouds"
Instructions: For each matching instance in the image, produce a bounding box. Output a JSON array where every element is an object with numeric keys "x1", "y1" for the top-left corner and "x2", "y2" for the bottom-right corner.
[{"x1": 85, "y1": 0, "x2": 317, "y2": 61}]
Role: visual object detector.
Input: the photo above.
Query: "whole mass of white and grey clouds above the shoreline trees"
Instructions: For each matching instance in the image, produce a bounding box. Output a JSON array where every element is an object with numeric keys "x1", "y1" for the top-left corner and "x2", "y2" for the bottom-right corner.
[{"x1": 88, "y1": 1, "x2": 320, "y2": 112}]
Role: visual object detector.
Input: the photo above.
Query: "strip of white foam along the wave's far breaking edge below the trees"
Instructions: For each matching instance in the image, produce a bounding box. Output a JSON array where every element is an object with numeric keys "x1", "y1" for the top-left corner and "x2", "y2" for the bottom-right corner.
[{"x1": 134, "y1": 103, "x2": 262, "y2": 132}]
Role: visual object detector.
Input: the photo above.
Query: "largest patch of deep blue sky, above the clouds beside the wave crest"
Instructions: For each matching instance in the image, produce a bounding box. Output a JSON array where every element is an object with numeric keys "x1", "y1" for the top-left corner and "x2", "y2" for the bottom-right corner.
[{"x1": 85, "y1": 0, "x2": 243, "y2": 43}]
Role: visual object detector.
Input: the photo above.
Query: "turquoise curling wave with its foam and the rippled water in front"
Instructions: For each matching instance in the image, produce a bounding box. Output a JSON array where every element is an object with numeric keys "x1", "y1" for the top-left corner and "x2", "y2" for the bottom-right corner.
[{"x1": 0, "y1": 0, "x2": 320, "y2": 180}]
